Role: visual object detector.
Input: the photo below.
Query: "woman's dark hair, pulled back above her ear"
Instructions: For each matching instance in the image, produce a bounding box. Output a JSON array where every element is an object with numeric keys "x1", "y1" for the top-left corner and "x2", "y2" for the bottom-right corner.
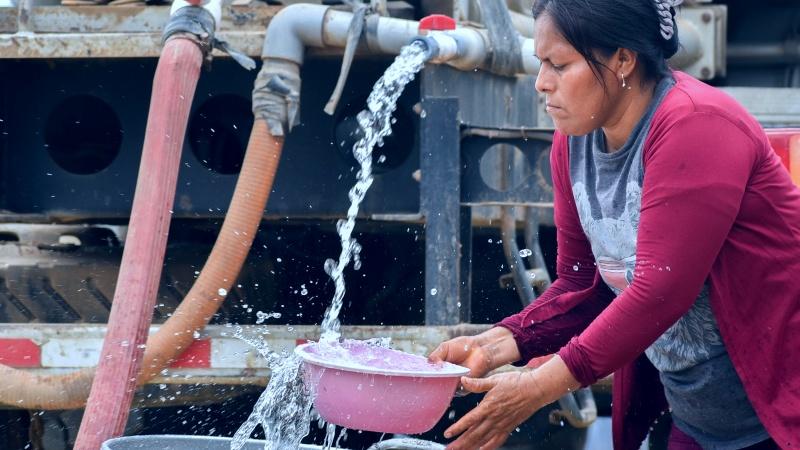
[{"x1": 533, "y1": 0, "x2": 679, "y2": 85}]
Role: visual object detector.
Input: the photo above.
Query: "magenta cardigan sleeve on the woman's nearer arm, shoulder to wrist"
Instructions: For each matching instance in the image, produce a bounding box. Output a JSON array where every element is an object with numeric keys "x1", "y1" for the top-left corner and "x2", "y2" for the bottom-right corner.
[{"x1": 559, "y1": 112, "x2": 758, "y2": 385}]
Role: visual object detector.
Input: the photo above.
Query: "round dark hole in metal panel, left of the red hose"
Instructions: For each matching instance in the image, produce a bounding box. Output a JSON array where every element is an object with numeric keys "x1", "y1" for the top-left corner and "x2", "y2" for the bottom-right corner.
[{"x1": 44, "y1": 95, "x2": 122, "y2": 175}]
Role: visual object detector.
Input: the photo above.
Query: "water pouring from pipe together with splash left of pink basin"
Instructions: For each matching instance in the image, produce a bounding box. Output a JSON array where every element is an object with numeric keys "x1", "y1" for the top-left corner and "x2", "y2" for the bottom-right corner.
[{"x1": 230, "y1": 43, "x2": 432, "y2": 450}]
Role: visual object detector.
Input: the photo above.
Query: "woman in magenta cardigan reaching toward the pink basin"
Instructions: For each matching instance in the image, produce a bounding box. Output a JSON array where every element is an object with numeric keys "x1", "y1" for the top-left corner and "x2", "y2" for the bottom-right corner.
[{"x1": 430, "y1": 0, "x2": 800, "y2": 450}]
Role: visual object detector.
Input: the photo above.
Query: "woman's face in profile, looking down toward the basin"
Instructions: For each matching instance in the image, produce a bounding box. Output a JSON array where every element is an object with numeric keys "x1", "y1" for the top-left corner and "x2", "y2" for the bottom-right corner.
[{"x1": 534, "y1": 14, "x2": 618, "y2": 136}]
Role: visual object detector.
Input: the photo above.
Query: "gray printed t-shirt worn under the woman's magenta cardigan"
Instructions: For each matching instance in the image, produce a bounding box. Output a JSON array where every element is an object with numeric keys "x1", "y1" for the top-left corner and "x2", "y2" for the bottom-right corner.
[{"x1": 569, "y1": 77, "x2": 769, "y2": 449}]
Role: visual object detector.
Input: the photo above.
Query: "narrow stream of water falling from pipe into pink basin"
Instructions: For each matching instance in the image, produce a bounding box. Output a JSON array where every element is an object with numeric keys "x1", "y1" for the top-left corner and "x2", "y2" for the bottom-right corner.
[{"x1": 320, "y1": 43, "x2": 432, "y2": 342}]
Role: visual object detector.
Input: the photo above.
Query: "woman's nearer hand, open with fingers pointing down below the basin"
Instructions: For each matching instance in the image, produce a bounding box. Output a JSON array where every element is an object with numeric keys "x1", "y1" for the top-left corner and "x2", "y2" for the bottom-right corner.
[{"x1": 444, "y1": 371, "x2": 545, "y2": 450}]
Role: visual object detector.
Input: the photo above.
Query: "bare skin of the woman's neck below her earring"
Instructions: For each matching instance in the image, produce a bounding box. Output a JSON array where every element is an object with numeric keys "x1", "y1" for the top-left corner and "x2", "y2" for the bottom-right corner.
[{"x1": 603, "y1": 80, "x2": 656, "y2": 153}]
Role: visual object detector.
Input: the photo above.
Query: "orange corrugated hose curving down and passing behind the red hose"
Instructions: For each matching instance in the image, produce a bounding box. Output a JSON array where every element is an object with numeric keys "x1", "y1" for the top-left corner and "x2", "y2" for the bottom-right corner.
[{"x1": 0, "y1": 119, "x2": 283, "y2": 409}]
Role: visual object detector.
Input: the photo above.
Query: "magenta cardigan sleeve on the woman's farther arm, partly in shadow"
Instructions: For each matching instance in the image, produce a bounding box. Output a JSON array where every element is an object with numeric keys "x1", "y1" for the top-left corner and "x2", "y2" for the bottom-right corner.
[{"x1": 497, "y1": 133, "x2": 613, "y2": 364}]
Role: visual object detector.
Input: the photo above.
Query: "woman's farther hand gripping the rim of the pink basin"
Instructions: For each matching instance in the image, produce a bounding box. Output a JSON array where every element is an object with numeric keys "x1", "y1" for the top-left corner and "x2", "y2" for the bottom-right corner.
[{"x1": 428, "y1": 327, "x2": 520, "y2": 377}]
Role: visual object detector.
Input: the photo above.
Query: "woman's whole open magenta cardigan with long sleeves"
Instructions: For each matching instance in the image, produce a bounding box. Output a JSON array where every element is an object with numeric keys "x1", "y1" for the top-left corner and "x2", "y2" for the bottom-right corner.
[{"x1": 498, "y1": 72, "x2": 800, "y2": 450}]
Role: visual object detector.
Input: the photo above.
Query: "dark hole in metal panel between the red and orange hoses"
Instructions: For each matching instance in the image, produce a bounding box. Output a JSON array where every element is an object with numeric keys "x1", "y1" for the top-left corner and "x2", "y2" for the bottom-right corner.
[{"x1": 189, "y1": 94, "x2": 253, "y2": 175}]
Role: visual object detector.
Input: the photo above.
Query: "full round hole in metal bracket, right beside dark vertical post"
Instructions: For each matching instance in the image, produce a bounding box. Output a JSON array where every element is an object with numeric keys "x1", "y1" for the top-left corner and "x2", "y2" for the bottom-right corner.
[{"x1": 479, "y1": 143, "x2": 533, "y2": 192}]
